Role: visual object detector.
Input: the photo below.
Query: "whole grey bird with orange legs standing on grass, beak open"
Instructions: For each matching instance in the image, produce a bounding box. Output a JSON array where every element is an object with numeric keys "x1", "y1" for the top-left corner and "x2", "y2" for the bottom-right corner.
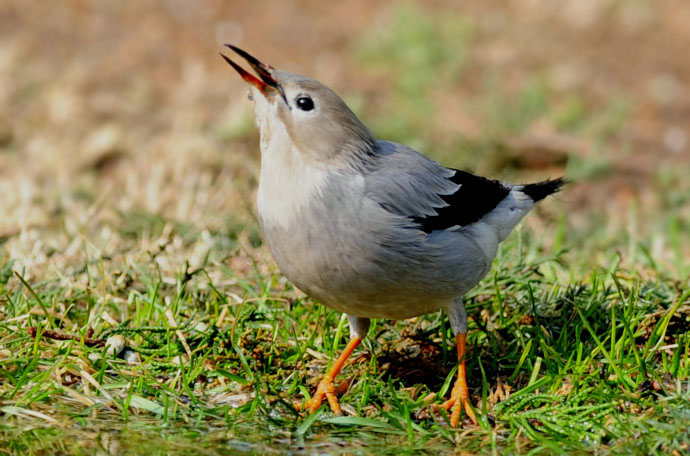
[{"x1": 220, "y1": 44, "x2": 566, "y2": 428}]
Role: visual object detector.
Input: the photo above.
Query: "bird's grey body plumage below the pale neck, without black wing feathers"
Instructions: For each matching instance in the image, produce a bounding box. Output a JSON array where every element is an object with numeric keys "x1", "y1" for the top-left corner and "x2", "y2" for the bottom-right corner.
[{"x1": 260, "y1": 142, "x2": 548, "y2": 328}]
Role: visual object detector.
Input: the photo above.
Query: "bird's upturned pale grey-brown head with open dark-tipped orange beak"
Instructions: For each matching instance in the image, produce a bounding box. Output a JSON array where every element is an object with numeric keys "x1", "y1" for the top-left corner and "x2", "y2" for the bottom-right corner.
[{"x1": 221, "y1": 44, "x2": 377, "y2": 166}]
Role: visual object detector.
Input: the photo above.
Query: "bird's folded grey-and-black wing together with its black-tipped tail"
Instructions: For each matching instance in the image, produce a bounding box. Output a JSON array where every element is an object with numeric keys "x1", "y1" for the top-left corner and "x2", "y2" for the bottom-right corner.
[{"x1": 366, "y1": 141, "x2": 565, "y2": 239}]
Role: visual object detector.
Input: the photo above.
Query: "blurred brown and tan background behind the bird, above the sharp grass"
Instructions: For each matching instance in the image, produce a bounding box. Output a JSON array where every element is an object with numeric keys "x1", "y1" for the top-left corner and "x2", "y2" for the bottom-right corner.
[{"x1": 0, "y1": 0, "x2": 690, "y2": 281}]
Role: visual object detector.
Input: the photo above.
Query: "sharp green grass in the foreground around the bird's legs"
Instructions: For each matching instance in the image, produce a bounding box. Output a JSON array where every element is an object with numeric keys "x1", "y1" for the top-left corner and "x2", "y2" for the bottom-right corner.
[{"x1": 0, "y1": 223, "x2": 690, "y2": 454}]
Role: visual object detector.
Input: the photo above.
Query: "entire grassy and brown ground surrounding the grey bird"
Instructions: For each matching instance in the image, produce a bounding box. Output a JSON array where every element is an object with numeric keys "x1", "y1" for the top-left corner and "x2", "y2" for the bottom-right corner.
[{"x1": 0, "y1": 0, "x2": 690, "y2": 454}]
